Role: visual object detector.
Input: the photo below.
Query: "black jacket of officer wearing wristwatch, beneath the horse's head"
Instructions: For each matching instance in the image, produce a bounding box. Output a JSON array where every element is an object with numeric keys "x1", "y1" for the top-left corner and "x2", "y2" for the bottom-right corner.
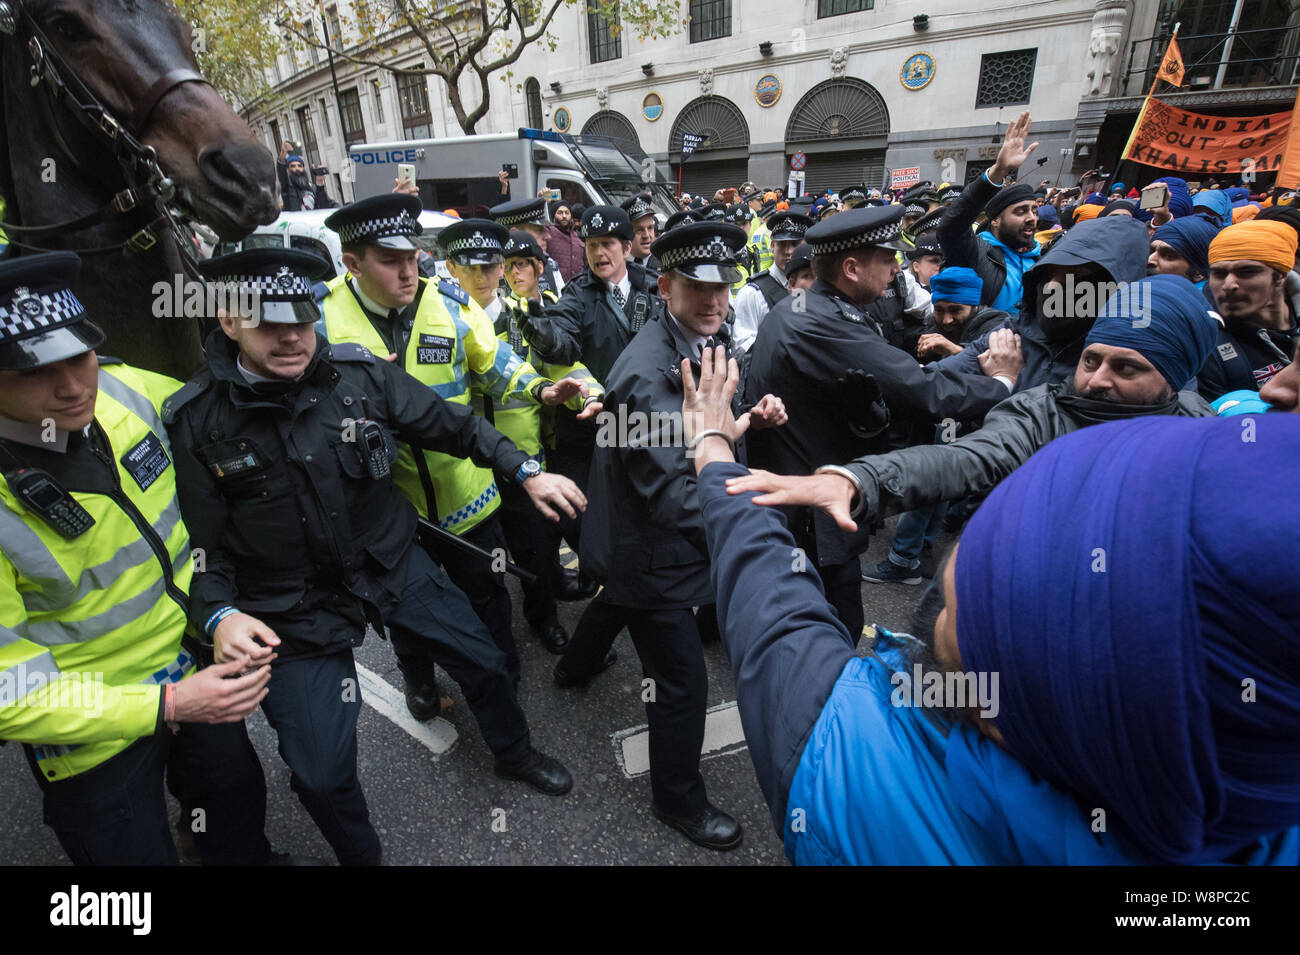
[{"x1": 163, "y1": 329, "x2": 528, "y2": 659}]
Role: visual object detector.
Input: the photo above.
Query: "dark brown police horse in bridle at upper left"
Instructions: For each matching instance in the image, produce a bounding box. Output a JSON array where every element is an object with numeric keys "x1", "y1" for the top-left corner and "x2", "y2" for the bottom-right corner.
[{"x1": 0, "y1": 0, "x2": 278, "y2": 378}]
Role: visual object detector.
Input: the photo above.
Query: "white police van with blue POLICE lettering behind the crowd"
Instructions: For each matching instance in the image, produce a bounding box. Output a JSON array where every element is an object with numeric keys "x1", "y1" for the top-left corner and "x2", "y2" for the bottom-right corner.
[{"x1": 347, "y1": 129, "x2": 679, "y2": 229}]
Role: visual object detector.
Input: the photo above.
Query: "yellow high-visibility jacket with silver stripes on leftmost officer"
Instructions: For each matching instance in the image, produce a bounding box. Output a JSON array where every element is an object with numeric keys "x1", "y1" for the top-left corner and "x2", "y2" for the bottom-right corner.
[{"x1": 0, "y1": 364, "x2": 194, "y2": 781}]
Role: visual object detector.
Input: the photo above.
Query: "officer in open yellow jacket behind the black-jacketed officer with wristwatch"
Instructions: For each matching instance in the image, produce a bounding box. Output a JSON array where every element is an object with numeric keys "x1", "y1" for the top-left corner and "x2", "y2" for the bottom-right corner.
[{"x1": 321, "y1": 195, "x2": 581, "y2": 720}]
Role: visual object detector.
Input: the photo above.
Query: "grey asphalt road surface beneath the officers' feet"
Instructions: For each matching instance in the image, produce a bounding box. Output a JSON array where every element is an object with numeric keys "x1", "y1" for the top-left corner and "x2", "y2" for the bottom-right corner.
[{"x1": 0, "y1": 514, "x2": 945, "y2": 865}]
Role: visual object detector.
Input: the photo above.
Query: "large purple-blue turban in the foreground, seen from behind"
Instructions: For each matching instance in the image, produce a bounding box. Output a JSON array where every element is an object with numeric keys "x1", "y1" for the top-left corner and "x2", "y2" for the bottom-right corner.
[{"x1": 956, "y1": 414, "x2": 1300, "y2": 864}]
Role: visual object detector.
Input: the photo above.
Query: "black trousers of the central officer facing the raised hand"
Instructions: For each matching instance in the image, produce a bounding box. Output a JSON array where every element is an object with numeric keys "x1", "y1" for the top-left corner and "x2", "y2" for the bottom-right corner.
[{"x1": 564, "y1": 592, "x2": 716, "y2": 816}]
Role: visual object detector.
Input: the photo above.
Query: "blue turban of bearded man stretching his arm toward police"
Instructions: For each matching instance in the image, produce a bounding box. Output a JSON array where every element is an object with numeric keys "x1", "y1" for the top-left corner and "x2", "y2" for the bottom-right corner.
[{"x1": 1084, "y1": 274, "x2": 1218, "y2": 391}]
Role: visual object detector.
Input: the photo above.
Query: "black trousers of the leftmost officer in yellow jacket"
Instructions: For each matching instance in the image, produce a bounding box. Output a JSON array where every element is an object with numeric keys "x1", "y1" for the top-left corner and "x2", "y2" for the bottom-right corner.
[{"x1": 25, "y1": 721, "x2": 270, "y2": 865}]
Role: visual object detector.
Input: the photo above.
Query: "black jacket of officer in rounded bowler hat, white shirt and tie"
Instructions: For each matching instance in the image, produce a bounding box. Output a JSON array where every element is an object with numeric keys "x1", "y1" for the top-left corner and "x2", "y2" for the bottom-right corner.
[{"x1": 524, "y1": 261, "x2": 664, "y2": 457}]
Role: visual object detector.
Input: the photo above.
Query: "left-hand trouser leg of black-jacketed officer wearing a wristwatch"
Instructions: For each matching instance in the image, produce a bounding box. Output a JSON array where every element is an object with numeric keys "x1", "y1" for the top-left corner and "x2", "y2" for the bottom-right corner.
[{"x1": 261, "y1": 650, "x2": 384, "y2": 865}]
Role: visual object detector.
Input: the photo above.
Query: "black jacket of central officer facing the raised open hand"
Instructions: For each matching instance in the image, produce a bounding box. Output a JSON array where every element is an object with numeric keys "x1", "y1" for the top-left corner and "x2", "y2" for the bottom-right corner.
[{"x1": 579, "y1": 314, "x2": 742, "y2": 609}]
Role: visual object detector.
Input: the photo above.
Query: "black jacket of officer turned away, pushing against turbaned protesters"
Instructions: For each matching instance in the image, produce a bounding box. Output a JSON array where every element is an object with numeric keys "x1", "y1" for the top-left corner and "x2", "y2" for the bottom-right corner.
[{"x1": 745, "y1": 279, "x2": 1008, "y2": 565}]
